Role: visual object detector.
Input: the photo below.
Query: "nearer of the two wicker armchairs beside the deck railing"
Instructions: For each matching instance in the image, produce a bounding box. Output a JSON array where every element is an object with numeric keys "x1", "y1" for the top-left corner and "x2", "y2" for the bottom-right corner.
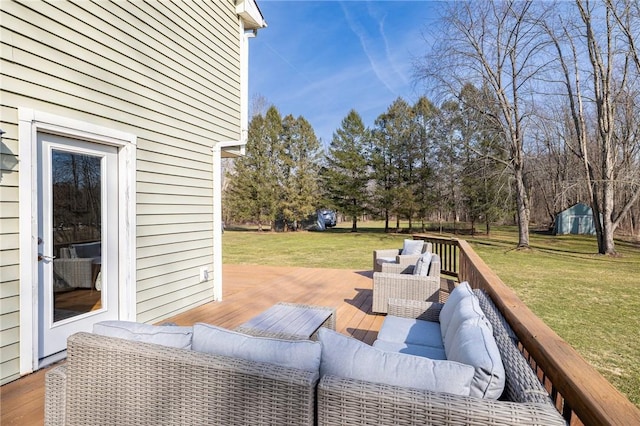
[{"x1": 372, "y1": 254, "x2": 440, "y2": 313}]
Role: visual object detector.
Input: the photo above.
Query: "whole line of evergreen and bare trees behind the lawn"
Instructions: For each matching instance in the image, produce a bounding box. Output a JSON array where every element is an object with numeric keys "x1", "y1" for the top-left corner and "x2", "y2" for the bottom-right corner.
[{"x1": 224, "y1": 0, "x2": 640, "y2": 254}]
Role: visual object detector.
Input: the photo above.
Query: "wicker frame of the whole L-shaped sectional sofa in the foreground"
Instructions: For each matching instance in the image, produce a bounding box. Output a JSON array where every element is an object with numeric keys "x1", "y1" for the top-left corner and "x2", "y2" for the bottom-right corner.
[{"x1": 45, "y1": 290, "x2": 566, "y2": 426}]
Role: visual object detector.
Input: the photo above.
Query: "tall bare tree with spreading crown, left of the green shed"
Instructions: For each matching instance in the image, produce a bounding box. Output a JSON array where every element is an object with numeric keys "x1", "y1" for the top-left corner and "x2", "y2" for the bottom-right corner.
[{"x1": 417, "y1": 1, "x2": 547, "y2": 247}]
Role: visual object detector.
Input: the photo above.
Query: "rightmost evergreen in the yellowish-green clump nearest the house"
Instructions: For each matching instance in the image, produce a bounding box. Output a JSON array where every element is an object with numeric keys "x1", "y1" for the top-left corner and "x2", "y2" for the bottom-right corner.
[{"x1": 281, "y1": 115, "x2": 320, "y2": 229}]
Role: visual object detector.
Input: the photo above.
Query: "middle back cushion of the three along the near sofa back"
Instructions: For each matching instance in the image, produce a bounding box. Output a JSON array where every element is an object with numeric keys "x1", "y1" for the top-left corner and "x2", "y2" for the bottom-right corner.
[{"x1": 192, "y1": 323, "x2": 322, "y2": 372}]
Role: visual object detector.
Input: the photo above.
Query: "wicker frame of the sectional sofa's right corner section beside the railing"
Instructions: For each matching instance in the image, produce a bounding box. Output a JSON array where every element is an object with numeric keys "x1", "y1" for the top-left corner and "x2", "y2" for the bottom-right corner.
[{"x1": 318, "y1": 290, "x2": 567, "y2": 426}]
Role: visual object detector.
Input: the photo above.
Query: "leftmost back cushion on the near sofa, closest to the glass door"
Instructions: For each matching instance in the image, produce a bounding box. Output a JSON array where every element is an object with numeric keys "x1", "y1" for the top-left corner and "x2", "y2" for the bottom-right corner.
[{"x1": 93, "y1": 321, "x2": 193, "y2": 349}]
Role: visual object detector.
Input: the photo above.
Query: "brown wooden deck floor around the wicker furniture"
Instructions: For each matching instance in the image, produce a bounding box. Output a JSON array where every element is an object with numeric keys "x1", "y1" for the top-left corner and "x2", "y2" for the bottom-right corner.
[{"x1": 5, "y1": 265, "x2": 436, "y2": 426}]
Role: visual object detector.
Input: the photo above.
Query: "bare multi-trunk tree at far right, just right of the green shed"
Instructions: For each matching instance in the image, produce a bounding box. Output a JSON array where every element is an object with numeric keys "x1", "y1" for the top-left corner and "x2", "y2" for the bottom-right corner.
[{"x1": 546, "y1": 0, "x2": 640, "y2": 254}]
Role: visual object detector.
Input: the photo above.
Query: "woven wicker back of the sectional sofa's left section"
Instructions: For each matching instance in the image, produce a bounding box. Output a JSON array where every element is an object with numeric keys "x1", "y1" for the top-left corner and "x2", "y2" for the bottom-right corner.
[{"x1": 47, "y1": 333, "x2": 318, "y2": 426}]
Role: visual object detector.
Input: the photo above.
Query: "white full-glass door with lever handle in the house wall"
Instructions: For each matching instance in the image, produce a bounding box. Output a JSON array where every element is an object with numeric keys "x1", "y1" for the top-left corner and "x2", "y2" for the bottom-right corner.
[{"x1": 38, "y1": 133, "x2": 118, "y2": 364}]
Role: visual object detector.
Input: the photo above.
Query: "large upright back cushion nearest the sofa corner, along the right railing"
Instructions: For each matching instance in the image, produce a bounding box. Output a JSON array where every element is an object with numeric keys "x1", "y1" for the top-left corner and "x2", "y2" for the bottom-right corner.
[{"x1": 445, "y1": 319, "x2": 505, "y2": 399}]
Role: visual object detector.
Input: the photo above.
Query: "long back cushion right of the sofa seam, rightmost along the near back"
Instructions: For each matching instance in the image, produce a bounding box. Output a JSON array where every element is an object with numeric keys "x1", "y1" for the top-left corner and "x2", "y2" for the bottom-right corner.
[{"x1": 318, "y1": 328, "x2": 474, "y2": 395}]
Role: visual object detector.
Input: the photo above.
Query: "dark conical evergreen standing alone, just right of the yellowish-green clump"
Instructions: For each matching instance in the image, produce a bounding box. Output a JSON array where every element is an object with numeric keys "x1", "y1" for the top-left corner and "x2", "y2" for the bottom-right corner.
[{"x1": 322, "y1": 110, "x2": 369, "y2": 232}]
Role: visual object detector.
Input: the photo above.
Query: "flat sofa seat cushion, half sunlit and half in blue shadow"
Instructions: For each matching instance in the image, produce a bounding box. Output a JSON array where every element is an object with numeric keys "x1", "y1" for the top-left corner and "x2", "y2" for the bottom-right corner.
[{"x1": 378, "y1": 315, "x2": 444, "y2": 349}]
